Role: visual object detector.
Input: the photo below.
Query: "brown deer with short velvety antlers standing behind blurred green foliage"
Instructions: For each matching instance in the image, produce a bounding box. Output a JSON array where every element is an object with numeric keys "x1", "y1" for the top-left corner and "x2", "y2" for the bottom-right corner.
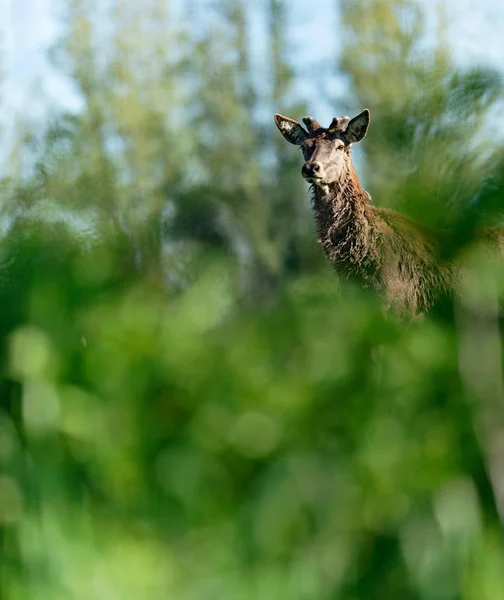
[{"x1": 274, "y1": 109, "x2": 504, "y2": 317}]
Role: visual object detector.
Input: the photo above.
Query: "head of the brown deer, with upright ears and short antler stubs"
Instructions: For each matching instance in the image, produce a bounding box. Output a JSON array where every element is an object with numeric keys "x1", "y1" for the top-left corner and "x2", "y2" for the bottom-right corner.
[{"x1": 275, "y1": 108, "x2": 369, "y2": 185}]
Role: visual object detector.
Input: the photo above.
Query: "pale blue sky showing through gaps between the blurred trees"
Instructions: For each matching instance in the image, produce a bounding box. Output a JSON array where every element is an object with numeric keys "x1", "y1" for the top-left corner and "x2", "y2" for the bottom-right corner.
[{"x1": 0, "y1": 0, "x2": 504, "y2": 162}]
